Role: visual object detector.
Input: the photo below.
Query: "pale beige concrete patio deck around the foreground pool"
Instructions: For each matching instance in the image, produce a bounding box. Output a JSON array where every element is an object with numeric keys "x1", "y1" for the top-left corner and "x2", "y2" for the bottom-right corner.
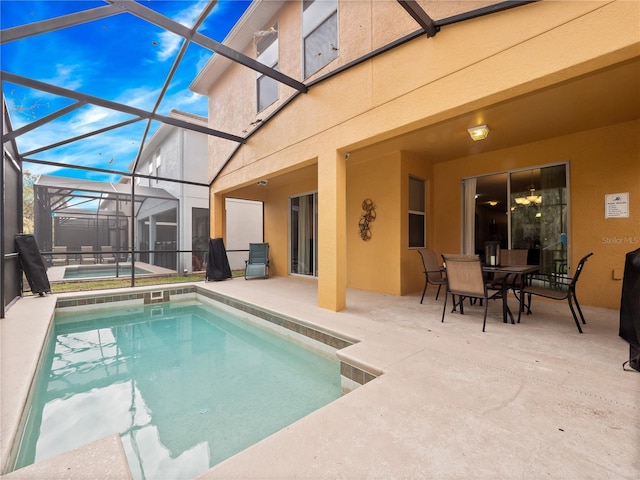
[{"x1": 1, "y1": 278, "x2": 640, "y2": 479}]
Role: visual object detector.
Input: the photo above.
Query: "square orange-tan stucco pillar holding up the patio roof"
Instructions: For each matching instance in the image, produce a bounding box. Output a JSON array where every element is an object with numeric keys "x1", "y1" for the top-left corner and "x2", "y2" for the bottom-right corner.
[{"x1": 318, "y1": 148, "x2": 347, "y2": 312}]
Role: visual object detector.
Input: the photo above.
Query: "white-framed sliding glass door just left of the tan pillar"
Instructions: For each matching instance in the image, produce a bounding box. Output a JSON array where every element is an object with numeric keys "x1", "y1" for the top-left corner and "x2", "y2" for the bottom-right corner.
[{"x1": 289, "y1": 193, "x2": 318, "y2": 277}]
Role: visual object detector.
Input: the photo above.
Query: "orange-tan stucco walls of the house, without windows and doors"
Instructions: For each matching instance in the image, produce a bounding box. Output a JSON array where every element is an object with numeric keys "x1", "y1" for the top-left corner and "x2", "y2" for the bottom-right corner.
[{"x1": 199, "y1": 1, "x2": 640, "y2": 310}]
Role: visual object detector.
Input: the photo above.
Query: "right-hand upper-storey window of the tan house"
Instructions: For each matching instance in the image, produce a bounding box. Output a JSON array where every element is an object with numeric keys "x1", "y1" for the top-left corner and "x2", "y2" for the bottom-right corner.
[{"x1": 302, "y1": 0, "x2": 338, "y2": 78}]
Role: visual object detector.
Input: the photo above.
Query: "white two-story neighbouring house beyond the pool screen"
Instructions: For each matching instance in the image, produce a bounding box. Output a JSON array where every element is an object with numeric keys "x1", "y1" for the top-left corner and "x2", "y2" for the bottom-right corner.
[{"x1": 134, "y1": 110, "x2": 262, "y2": 273}]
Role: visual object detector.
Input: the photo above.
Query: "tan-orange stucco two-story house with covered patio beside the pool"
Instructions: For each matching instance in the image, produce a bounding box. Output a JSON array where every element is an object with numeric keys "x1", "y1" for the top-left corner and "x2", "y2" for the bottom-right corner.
[{"x1": 191, "y1": 0, "x2": 640, "y2": 310}]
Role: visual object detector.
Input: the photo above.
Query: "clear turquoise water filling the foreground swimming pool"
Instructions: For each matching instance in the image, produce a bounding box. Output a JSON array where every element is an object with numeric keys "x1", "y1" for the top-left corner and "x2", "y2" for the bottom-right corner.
[{"x1": 16, "y1": 302, "x2": 341, "y2": 479}]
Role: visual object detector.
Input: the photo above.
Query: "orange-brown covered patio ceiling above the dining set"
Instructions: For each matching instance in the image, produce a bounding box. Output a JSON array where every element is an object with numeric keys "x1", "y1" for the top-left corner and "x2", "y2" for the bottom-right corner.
[{"x1": 352, "y1": 59, "x2": 640, "y2": 163}]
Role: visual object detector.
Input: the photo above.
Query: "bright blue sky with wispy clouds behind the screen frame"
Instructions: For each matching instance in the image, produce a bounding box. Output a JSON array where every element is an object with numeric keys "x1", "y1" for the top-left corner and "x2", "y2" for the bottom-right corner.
[{"x1": 0, "y1": 0, "x2": 251, "y2": 180}]
